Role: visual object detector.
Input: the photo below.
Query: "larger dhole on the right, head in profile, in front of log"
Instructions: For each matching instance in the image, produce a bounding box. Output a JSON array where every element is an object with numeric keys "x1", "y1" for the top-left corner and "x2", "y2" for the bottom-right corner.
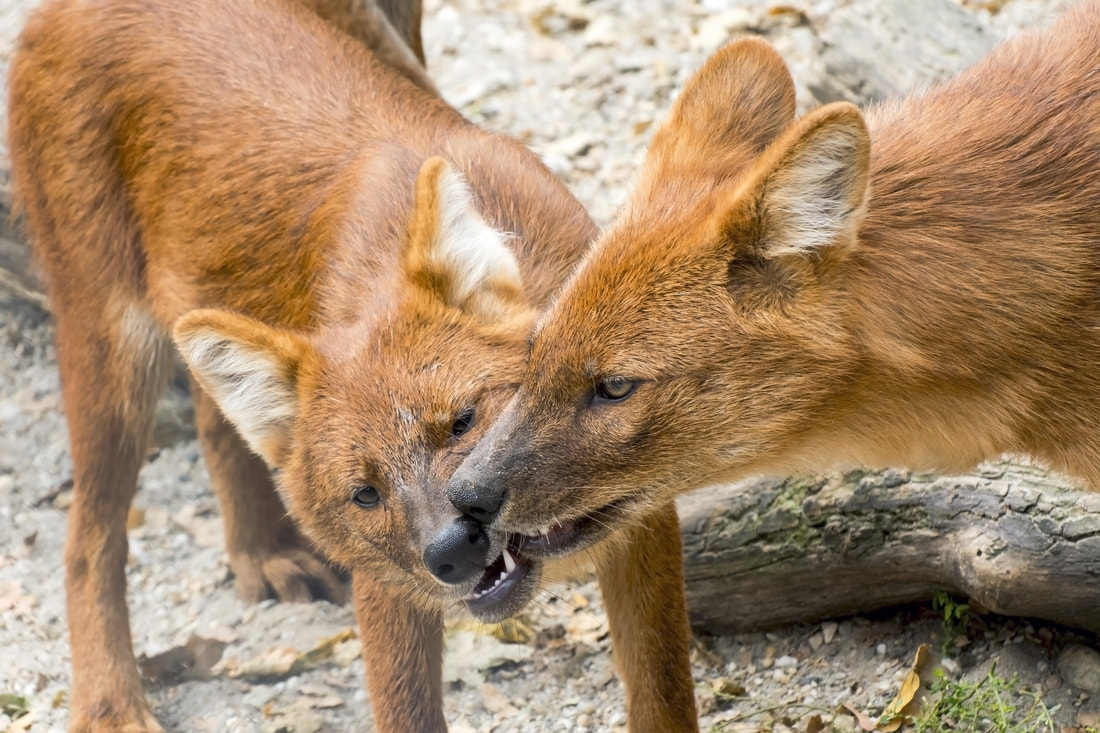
[{"x1": 449, "y1": 0, "x2": 1100, "y2": 669}]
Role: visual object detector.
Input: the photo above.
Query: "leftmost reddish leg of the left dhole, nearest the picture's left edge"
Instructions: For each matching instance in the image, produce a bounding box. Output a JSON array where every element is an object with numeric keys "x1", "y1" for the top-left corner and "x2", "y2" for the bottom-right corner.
[{"x1": 56, "y1": 303, "x2": 168, "y2": 733}]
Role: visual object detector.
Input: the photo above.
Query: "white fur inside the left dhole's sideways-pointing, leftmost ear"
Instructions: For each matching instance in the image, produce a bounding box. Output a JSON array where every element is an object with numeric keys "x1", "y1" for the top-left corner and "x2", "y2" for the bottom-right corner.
[{"x1": 175, "y1": 317, "x2": 298, "y2": 467}]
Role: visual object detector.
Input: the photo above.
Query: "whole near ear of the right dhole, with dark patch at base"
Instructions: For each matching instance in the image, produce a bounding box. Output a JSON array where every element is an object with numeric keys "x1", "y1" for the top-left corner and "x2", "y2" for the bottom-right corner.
[{"x1": 714, "y1": 102, "x2": 870, "y2": 307}]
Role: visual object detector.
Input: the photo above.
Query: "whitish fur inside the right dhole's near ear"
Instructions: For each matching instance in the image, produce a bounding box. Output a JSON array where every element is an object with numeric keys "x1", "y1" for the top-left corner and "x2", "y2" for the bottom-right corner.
[{"x1": 758, "y1": 108, "x2": 870, "y2": 258}]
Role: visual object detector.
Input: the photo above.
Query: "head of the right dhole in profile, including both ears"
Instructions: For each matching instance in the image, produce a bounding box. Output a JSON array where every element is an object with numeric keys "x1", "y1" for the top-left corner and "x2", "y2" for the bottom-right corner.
[{"x1": 449, "y1": 41, "x2": 869, "y2": 572}]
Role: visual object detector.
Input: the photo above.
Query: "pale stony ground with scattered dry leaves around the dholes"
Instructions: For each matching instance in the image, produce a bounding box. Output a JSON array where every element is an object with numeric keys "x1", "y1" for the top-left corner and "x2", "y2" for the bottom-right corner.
[{"x1": 0, "y1": 0, "x2": 1100, "y2": 733}]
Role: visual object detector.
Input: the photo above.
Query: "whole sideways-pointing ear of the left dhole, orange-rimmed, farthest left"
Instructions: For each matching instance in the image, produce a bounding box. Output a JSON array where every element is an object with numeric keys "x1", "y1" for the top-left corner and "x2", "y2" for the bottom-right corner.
[{"x1": 173, "y1": 310, "x2": 314, "y2": 468}]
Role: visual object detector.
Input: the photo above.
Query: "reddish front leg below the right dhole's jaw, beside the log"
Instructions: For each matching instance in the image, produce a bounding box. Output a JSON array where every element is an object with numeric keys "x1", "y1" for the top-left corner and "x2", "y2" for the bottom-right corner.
[{"x1": 596, "y1": 503, "x2": 699, "y2": 733}]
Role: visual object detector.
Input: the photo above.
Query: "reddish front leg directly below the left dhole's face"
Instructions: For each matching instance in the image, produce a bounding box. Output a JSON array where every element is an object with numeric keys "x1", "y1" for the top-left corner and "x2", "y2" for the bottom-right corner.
[{"x1": 352, "y1": 571, "x2": 447, "y2": 733}]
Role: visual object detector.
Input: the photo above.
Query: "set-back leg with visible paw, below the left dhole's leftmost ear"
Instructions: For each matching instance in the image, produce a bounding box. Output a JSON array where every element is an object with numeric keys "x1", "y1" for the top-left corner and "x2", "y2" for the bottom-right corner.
[{"x1": 191, "y1": 379, "x2": 348, "y2": 603}]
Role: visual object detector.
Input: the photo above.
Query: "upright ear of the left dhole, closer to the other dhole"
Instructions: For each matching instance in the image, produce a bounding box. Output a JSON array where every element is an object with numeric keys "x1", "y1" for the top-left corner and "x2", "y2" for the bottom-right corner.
[{"x1": 405, "y1": 157, "x2": 529, "y2": 324}]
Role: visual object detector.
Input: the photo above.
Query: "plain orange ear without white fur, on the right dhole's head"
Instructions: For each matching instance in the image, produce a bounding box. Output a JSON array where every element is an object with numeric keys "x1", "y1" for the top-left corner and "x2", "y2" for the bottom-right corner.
[{"x1": 641, "y1": 39, "x2": 794, "y2": 189}]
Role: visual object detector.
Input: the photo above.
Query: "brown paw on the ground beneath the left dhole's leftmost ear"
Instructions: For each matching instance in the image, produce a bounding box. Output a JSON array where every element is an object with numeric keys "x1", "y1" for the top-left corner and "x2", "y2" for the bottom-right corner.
[{"x1": 230, "y1": 544, "x2": 348, "y2": 603}]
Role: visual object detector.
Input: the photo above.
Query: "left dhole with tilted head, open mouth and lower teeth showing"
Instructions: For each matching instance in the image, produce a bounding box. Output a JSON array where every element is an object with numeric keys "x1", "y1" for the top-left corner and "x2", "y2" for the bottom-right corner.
[{"x1": 10, "y1": 0, "x2": 694, "y2": 733}]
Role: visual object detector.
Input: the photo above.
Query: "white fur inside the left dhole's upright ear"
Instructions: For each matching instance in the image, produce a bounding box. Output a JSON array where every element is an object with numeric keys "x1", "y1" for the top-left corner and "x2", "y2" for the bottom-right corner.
[{"x1": 428, "y1": 163, "x2": 523, "y2": 305}]
